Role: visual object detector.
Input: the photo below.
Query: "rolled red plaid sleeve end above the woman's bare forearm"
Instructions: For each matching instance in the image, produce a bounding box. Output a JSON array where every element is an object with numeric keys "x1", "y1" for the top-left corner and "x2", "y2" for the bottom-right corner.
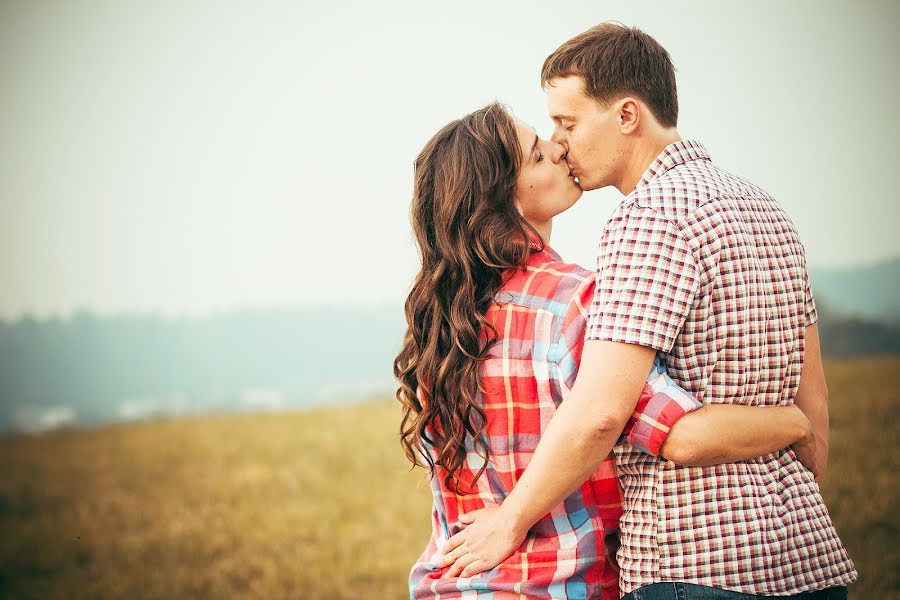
[{"x1": 619, "y1": 355, "x2": 703, "y2": 456}]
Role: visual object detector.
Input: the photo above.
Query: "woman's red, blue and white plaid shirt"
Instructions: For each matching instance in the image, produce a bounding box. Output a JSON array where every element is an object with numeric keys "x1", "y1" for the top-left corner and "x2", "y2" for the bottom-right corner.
[{"x1": 409, "y1": 248, "x2": 701, "y2": 600}]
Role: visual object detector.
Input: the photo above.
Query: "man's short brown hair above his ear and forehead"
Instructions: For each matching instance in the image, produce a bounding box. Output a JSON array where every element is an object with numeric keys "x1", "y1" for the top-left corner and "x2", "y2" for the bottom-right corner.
[{"x1": 541, "y1": 22, "x2": 678, "y2": 127}]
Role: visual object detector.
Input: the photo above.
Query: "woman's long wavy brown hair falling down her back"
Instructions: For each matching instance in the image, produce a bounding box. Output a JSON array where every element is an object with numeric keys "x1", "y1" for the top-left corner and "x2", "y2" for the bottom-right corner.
[{"x1": 394, "y1": 103, "x2": 540, "y2": 493}]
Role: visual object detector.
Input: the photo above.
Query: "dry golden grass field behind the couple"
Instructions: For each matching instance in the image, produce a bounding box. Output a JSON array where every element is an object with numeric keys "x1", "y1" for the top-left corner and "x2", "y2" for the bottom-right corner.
[{"x1": 0, "y1": 357, "x2": 900, "y2": 600}]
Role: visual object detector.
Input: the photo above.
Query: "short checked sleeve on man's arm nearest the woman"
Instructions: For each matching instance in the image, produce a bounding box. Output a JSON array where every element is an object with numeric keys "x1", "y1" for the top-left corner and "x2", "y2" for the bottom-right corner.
[{"x1": 586, "y1": 205, "x2": 700, "y2": 352}]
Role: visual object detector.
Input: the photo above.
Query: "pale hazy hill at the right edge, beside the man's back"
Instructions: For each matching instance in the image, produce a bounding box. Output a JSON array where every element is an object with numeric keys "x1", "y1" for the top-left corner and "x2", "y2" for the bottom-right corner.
[{"x1": 809, "y1": 258, "x2": 900, "y2": 323}]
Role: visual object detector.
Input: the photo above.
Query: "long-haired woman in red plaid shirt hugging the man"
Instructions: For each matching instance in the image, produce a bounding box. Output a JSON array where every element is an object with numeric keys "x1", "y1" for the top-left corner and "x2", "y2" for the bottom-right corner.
[{"x1": 394, "y1": 104, "x2": 810, "y2": 600}]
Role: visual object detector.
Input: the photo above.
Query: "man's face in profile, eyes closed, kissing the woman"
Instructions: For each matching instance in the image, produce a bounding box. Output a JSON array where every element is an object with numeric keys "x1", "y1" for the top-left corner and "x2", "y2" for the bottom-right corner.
[{"x1": 544, "y1": 75, "x2": 625, "y2": 190}]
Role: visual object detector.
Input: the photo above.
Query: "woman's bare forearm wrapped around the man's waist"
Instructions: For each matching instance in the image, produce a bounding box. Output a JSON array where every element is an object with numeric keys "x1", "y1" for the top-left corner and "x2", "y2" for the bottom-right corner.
[{"x1": 660, "y1": 404, "x2": 813, "y2": 466}]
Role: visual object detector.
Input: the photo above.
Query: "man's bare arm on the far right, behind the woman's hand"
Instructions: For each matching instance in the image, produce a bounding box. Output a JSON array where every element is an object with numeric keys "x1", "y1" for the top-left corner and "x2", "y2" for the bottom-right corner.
[{"x1": 794, "y1": 323, "x2": 828, "y2": 479}]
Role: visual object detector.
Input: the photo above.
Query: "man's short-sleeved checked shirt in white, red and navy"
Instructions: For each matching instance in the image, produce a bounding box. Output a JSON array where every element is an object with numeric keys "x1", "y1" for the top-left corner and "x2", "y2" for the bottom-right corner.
[{"x1": 587, "y1": 141, "x2": 856, "y2": 595}]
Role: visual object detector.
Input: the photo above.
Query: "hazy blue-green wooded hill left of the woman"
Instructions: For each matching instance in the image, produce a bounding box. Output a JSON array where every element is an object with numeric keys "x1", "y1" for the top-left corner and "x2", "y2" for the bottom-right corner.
[{"x1": 0, "y1": 306, "x2": 404, "y2": 431}]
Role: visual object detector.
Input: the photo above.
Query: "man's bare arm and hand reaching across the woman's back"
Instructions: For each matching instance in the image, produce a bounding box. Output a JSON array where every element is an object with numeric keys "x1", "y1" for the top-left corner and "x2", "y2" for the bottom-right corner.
[{"x1": 441, "y1": 340, "x2": 656, "y2": 577}]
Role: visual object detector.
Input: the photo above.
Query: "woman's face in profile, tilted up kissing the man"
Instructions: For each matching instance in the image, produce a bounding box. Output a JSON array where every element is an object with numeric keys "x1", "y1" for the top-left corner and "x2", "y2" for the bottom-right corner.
[{"x1": 515, "y1": 119, "x2": 582, "y2": 231}]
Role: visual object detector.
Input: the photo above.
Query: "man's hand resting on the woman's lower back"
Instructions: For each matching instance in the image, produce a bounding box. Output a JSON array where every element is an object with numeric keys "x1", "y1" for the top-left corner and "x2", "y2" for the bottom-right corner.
[{"x1": 438, "y1": 506, "x2": 528, "y2": 577}]
